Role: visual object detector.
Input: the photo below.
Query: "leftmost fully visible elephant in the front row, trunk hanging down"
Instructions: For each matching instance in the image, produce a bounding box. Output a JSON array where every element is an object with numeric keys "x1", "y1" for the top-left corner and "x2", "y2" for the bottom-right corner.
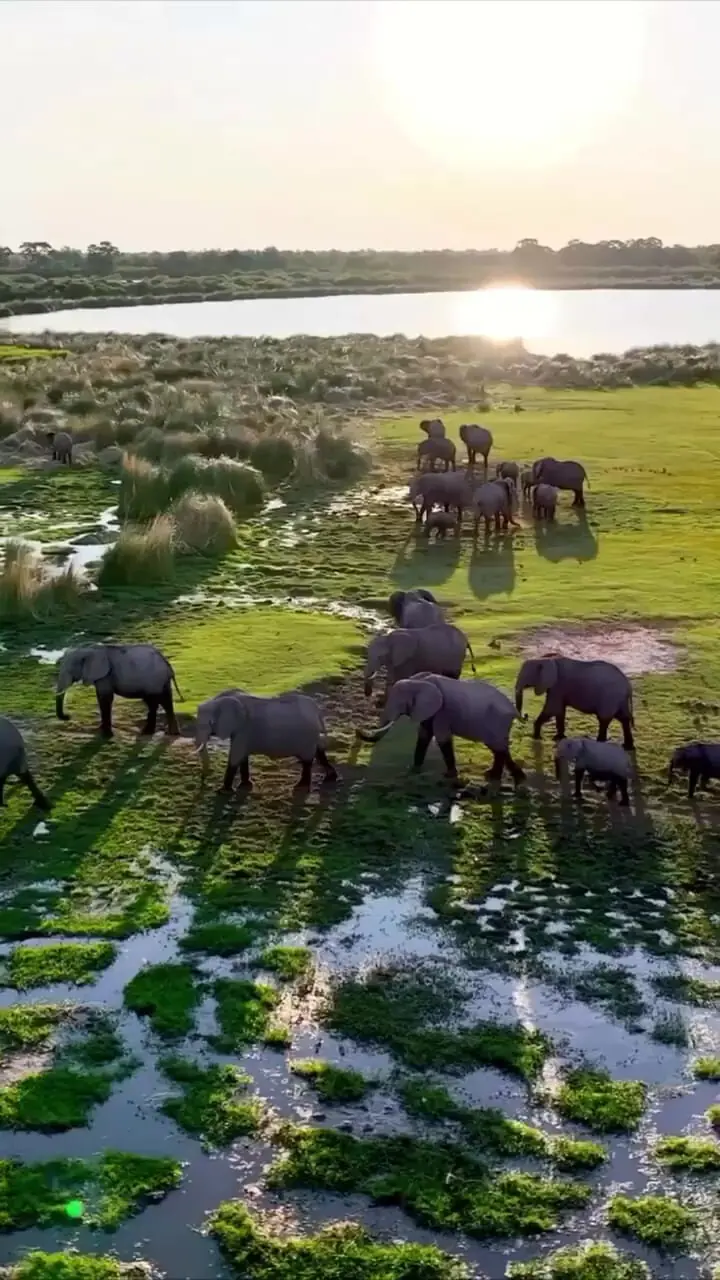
[{"x1": 55, "y1": 644, "x2": 182, "y2": 737}]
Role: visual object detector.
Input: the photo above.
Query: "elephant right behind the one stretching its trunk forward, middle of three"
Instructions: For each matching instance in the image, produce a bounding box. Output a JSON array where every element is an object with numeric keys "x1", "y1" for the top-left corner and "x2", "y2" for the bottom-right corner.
[{"x1": 364, "y1": 622, "x2": 475, "y2": 698}]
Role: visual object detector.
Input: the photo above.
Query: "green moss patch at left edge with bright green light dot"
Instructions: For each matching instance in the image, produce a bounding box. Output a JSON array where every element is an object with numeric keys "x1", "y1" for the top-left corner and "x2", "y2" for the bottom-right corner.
[{"x1": 0, "y1": 1151, "x2": 182, "y2": 1231}]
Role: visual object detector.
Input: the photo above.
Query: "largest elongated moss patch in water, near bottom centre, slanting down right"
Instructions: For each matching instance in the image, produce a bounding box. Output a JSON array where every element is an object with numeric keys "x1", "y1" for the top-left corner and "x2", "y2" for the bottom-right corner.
[{"x1": 268, "y1": 1125, "x2": 591, "y2": 1236}]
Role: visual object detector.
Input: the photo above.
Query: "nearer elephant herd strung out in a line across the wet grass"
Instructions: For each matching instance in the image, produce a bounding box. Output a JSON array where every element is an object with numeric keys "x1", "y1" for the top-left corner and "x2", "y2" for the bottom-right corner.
[{"x1": 0, "y1": 589, "x2": 720, "y2": 809}]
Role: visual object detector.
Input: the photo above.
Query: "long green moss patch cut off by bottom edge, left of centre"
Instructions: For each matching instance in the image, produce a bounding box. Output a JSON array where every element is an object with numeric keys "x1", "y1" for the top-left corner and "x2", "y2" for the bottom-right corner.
[{"x1": 210, "y1": 1202, "x2": 469, "y2": 1280}]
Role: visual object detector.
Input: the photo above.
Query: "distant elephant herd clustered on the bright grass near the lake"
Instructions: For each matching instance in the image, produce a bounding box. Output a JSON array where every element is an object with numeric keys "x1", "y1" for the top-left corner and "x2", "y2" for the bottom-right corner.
[{"x1": 407, "y1": 417, "x2": 587, "y2": 539}]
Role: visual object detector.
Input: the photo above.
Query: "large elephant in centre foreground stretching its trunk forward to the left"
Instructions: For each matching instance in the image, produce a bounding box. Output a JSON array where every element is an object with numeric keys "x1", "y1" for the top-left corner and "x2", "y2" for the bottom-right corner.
[{"x1": 356, "y1": 673, "x2": 525, "y2": 786}]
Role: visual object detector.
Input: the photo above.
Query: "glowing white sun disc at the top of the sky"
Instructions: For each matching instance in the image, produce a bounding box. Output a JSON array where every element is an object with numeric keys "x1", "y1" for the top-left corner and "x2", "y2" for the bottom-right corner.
[{"x1": 373, "y1": 0, "x2": 652, "y2": 169}]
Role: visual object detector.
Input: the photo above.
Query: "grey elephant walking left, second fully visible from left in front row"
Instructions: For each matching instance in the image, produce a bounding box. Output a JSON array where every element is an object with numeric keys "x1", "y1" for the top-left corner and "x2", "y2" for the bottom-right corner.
[{"x1": 195, "y1": 689, "x2": 337, "y2": 791}]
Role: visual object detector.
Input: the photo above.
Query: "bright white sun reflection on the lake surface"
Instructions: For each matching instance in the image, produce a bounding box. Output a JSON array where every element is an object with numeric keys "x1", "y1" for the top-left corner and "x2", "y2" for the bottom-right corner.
[{"x1": 456, "y1": 284, "x2": 557, "y2": 342}]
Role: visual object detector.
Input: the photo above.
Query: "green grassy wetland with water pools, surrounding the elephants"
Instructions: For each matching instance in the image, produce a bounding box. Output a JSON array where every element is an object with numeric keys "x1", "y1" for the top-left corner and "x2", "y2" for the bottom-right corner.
[{"x1": 0, "y1": 335, "x2": 720, "y2": 1280}]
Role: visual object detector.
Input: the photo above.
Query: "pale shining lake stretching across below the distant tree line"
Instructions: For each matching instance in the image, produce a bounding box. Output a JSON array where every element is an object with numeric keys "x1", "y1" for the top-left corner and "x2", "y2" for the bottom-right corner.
[{"x1": 0, "y1": 285, "x2": 720, "y2": 356}]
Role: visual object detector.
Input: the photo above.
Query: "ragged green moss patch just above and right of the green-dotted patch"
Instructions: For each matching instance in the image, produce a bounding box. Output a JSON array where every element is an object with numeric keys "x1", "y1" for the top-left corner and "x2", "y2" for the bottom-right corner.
[{"x1": 160, "y1": 1057, "x2": 263, "y2": 1147}]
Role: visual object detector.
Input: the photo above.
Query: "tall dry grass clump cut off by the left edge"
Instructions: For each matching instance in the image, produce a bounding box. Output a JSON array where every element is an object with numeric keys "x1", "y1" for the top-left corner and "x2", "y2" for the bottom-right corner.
[{"x1": 0, "y1": 541, "x2": 86, "y2": 621}]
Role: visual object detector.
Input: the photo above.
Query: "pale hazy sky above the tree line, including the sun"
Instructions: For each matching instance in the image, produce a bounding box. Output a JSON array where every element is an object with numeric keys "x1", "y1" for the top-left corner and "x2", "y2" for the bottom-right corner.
[{"x1": 0, "y1": 0, "x2": 720, "y2": 250}]
